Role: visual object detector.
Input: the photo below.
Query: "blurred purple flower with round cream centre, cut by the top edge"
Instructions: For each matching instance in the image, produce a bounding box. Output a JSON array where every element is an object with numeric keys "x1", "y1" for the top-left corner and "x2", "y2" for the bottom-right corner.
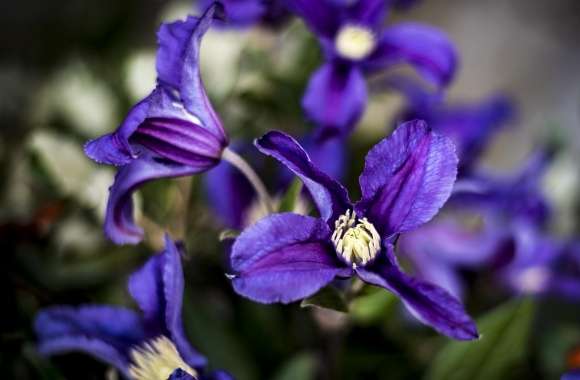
[{"x1": 288, "y1": 0, "x2": 457, "y2": 134}]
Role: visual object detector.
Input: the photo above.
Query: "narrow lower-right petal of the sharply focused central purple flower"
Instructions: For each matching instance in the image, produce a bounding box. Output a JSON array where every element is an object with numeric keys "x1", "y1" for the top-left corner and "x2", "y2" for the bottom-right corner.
[{"x1": 356, "y1": 251, "x2": 478, "y2": 340}]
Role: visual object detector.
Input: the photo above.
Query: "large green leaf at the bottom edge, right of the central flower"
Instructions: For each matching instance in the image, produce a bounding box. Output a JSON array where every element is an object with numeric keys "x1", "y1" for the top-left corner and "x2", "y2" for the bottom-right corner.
[{"x1": 427, "y1": 299, "x2": 534, "y2": 380}]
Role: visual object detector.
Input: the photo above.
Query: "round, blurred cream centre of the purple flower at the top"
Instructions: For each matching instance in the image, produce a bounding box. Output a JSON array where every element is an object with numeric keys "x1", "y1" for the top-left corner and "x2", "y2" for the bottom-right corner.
[{"x1": 334, "y1": 25, "x2": 376, "y2": 60}]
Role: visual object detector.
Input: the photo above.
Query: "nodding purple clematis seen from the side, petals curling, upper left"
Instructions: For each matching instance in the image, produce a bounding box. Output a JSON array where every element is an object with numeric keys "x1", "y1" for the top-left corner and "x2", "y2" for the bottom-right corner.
[{"x1": 85, "y1": 5, "x2": 228, "y2": 244}]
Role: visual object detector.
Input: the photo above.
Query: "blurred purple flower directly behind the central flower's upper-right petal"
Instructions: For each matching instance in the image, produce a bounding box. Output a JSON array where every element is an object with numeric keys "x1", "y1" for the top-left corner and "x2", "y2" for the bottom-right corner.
[{"x1": 387, "y1": 77, "x2": 515, "y2": 175}]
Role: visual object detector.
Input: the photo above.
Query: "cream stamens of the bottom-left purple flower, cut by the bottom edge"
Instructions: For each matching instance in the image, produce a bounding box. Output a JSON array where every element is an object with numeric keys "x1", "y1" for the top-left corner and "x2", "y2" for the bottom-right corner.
[{"x1": 129, "y1": 336, "x2": 197, "y2": 380}]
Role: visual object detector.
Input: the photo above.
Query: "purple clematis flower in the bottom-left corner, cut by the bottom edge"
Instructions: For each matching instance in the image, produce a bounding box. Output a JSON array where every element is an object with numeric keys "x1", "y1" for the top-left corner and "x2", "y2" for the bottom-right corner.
[{"x1": 35, "y1": 236, "x2": 233, "y2": 380}]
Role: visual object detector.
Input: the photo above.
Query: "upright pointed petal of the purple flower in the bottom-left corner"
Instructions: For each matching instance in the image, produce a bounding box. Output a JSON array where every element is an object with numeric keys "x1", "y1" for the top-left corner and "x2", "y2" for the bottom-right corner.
[{"x1": 129, "y1": 235, "x2": 206, "y2": 367}]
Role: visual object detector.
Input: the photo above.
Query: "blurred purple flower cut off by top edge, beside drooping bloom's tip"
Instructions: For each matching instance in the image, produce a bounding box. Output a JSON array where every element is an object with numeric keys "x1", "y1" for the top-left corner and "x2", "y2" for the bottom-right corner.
[{"x1": 199, "y1": 0, "x2": 290, "y2": 27}]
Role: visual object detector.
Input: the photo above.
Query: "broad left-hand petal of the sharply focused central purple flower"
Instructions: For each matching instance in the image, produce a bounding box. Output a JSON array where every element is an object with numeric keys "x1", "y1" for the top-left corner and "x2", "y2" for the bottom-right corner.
[{"x1": 231, "y1": 213, "x2": 348, "y2": 303}]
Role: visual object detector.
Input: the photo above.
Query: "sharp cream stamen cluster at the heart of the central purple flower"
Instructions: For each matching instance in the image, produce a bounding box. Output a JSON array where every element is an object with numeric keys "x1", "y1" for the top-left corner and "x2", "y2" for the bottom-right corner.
[{"x1": 332, "y1": 210, "x2": 381, "y2": 268}]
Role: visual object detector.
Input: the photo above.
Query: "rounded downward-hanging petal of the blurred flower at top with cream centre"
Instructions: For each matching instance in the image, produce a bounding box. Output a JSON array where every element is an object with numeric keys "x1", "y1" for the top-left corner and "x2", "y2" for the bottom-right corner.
[{"x1": 302, "y1": 63, "x2": 367, "y2": 135}]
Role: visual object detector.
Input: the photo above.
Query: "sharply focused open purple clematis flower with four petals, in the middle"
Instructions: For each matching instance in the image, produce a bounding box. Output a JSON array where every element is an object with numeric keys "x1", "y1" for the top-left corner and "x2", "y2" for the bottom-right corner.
[{"x1": 231, "y1": 121, "x2": 478, "y2": 340}]
